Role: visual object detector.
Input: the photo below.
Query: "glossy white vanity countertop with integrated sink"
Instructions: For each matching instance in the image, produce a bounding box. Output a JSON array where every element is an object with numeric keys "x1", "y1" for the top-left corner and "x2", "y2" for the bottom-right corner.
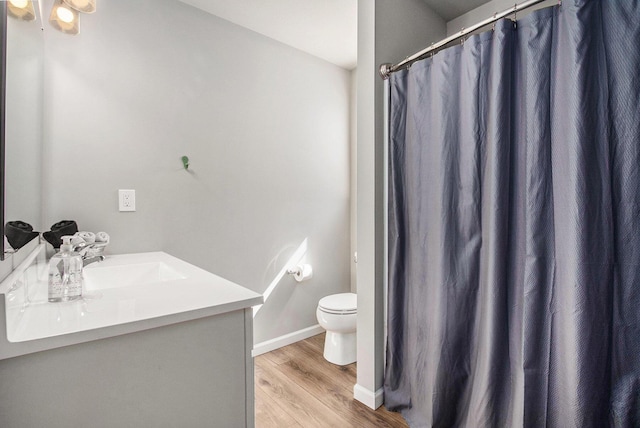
[{"x1": 0, "y1": 247, "x2": 263, "y2": 357}]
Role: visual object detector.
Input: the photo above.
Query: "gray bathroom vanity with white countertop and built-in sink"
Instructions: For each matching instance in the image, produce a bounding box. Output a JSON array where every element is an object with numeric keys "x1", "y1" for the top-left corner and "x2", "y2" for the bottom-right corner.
[{"x1": 0, "y1": 245, "x2": 262, "y2": 428}]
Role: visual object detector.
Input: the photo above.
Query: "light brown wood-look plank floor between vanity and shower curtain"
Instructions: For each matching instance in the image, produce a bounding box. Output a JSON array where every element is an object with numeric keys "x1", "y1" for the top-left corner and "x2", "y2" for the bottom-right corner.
[{"x1": 255, "y1": 334, "x2": 408, "y2": 428}]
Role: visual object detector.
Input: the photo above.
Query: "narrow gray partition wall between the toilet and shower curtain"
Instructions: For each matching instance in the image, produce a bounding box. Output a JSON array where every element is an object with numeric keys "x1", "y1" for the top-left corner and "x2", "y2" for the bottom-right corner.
[{"x1": 356, "y1": 0, "x2": 445, "y2": 407}]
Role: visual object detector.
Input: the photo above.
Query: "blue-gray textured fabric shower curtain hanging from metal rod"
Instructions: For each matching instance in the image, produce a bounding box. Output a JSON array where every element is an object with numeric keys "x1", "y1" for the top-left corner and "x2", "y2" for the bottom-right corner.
[{"x1": 384, "y1": 0, "x2": 640, "y2": 428}]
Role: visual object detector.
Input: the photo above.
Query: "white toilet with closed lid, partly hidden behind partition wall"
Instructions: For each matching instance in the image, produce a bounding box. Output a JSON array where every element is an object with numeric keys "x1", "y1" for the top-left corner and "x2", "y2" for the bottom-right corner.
[{"x1": 316, "y1": 293, "x2": 358, "y2": 366}]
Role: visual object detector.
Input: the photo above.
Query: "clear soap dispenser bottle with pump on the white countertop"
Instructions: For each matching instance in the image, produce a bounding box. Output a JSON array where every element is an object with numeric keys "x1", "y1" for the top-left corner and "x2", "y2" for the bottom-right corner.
[{"x1": 49, "y1": 236, "x2": 82, "y2": 302}]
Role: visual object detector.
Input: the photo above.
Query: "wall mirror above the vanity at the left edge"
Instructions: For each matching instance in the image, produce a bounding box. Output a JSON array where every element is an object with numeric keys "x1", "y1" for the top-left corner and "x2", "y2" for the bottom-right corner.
[{"x1": 0, "y1": 1, "x2": 44, "y2": 259}]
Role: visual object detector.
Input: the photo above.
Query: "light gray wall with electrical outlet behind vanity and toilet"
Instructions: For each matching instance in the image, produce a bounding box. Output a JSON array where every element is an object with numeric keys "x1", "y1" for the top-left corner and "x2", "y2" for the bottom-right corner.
[{"x1": 44, "y1": 0, "x2": 351, "y2": 343}]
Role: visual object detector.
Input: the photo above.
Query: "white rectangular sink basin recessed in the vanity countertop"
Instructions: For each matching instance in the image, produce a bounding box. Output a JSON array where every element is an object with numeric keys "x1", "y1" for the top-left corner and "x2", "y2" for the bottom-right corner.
[{"x1": 83, "y1": 262, "x2": 187, "y2": 290}]
